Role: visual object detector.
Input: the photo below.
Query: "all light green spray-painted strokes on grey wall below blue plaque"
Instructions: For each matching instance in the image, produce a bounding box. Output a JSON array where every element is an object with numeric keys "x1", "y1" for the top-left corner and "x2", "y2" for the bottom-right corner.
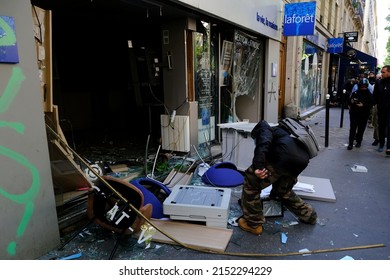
[{"x1": 0, "y1": 66, "x2": 41, "y2": 255}]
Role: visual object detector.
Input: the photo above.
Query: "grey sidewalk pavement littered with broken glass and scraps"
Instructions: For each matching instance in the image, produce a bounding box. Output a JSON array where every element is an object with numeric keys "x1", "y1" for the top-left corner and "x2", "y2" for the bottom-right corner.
[{"x1": 40, "y1": 108, "x2": 390, "y2": 260}]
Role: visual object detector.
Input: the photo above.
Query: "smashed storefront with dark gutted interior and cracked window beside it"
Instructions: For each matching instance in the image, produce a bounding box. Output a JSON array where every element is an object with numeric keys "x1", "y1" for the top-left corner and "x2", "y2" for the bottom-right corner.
[{"x1": 27, "y1": 0, "x2": 284, "y2": 152}]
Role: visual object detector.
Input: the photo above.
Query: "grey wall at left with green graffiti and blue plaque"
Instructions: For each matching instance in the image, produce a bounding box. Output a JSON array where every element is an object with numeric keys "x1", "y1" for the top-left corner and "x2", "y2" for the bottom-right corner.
[{"x1": 0, "y1": 0, "x2": 60, "y2": 259}]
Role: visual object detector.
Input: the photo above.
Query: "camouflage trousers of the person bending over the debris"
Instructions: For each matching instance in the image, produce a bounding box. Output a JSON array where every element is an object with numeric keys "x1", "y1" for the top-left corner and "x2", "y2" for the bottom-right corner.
[{"x1": 241, "y1": 166, "x2": 317, "y2": 226}]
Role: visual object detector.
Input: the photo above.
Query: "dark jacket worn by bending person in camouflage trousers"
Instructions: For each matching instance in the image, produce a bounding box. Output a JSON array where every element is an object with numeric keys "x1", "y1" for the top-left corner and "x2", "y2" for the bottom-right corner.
[{"x1": 251, "y1": 120, "x2": 309, "y2": 176}]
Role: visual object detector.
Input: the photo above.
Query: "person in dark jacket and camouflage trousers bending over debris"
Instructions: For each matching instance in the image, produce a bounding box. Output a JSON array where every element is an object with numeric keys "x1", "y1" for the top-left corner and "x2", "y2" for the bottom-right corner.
[{"x1": 238, "y1": 120, "x2": 317, "y2": 235}]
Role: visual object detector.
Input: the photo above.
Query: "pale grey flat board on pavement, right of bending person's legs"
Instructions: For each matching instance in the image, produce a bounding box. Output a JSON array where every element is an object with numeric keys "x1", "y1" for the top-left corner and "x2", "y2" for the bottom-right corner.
[{"x1": 294, "y1": 176, "x2": 336, "y2": 202}]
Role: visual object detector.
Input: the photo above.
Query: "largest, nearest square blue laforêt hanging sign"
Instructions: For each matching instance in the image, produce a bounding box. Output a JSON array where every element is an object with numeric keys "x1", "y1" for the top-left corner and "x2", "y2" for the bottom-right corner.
[{"x1": 283, "y1": 2, "x2": 316, "y2": 36}]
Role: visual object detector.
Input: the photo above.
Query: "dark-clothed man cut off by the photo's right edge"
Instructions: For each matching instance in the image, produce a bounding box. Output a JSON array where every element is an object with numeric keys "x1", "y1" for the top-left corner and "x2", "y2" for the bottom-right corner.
[{"x1": 374, "y1": 65, "x2": 390, "y2": 155}]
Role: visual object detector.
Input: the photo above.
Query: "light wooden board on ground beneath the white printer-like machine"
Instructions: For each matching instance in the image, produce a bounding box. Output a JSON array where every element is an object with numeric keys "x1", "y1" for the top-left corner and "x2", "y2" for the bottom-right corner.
[{"x1": 139, "y1": 219, "x2": 233, "y2": 252}]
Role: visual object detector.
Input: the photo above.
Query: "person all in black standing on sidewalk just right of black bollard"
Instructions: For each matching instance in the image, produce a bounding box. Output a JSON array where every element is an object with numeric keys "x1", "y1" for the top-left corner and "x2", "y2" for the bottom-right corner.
[{"x1": 347, "y1": 78, "x2": 373, "y2": 150}]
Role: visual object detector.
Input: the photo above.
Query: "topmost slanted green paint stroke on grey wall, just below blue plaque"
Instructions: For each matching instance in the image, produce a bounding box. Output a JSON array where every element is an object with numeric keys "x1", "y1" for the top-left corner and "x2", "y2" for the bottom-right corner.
[{"x1": 0, "y1": 67, "x2": 26, "y2": 113}]
